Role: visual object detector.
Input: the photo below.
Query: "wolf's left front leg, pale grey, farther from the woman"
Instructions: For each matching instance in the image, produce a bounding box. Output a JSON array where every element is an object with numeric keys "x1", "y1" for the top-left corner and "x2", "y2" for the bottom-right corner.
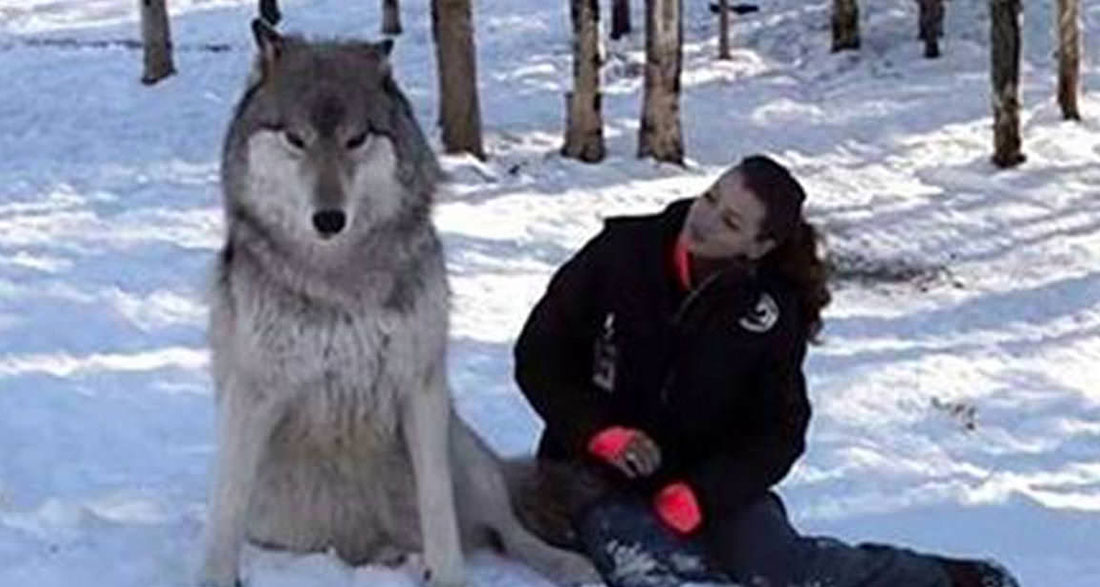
[{"x1": 199, "y1": 389, "x2": 281, "y2": 587}]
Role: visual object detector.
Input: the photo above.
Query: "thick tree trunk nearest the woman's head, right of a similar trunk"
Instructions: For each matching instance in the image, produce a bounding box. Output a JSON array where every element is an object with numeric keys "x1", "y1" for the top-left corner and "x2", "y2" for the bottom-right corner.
[{"x1": 638, "y1": 0, "x2": 684, "y2": 165}]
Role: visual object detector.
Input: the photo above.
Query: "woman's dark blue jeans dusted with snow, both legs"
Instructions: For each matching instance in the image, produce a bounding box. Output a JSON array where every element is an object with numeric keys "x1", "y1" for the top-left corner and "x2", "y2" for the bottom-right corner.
[{"x1": 578, "y1": 494, "x2": 952, "y2": 587}]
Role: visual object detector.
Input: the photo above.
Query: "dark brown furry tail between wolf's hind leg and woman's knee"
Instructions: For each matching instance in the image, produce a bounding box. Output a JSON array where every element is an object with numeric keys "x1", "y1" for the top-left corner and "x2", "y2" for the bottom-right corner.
[{"x1": 501, "y1": 458, "x2": 607, "y2": 551}]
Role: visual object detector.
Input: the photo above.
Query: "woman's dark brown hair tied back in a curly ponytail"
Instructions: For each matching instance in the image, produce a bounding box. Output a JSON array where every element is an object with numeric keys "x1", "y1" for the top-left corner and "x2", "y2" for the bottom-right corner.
[{"x1": 737, "y1": 155, "x2": 832, "y2": 340}]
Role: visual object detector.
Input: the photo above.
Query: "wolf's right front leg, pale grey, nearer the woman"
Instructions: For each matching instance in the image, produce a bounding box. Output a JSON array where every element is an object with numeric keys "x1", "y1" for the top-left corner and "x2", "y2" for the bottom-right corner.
[{"x1": 402, "y1": 384, "x2": 465, "y2": 587}]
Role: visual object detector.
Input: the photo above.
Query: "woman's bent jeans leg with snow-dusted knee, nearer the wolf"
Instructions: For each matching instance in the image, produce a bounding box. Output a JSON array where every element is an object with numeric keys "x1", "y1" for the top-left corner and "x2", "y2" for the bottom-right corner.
[{"x1": 576, "y1": 496, "x2": 729, "y2": 587}]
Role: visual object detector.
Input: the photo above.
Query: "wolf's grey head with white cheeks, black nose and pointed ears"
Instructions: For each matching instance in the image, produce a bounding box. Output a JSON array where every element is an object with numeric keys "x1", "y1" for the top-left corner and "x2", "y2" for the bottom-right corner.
[{"x1": 222, "y1": 20, "x2": 439, "y2": 253}]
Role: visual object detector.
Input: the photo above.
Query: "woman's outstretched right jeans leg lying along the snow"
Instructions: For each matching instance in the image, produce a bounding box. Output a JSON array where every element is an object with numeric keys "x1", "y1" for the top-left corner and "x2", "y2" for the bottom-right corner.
[{"x1": 706, "y1": 494, "x2": 950, "y2": 587}]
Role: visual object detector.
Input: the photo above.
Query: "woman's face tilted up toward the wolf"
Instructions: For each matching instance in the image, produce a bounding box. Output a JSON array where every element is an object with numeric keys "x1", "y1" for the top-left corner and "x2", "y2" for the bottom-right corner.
[{"x1": 683, "y1": 168, "x2": 776, "y2": 261}]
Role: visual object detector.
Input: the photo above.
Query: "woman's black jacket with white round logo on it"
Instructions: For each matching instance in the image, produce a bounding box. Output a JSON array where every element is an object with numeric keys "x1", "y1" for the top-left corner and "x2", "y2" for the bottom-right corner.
[{"x1": 515, "y1": 200, "x2": 810, "y2": 519}]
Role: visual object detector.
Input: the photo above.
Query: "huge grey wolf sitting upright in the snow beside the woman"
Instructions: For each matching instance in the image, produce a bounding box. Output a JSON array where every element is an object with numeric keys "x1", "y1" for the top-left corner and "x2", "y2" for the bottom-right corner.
[{"x1": 200, "y1": 20, "x2": 596, "y2": 587}]
